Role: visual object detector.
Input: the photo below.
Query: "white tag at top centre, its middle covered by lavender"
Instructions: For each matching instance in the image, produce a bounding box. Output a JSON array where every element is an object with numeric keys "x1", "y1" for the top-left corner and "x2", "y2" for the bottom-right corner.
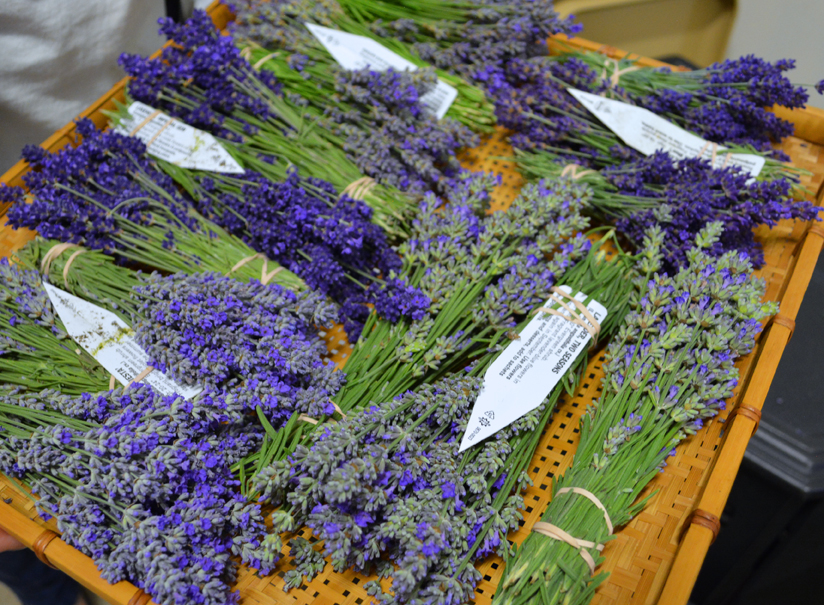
[{"x1": 305, "y1": 23, "x2": 458, "y2": 119}]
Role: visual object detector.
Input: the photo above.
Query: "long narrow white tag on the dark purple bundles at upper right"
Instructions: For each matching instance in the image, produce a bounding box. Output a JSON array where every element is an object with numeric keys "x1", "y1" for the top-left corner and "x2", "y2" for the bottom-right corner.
[{"x1": 567, "y1": 88, "x2": 766, "y2": 178}]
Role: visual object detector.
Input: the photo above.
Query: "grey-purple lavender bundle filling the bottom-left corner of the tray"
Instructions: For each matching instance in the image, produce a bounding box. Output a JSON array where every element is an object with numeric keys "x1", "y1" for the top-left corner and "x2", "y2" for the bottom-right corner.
[{"x1": 0, "y1": 384, "x2": 273, "y2": 605}]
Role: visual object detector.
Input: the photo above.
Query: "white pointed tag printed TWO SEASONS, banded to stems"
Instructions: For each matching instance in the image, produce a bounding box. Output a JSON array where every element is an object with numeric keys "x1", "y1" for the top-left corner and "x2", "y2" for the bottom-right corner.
[{"x1": 458, "y1": 286, "x2": 607, "y2": 452}]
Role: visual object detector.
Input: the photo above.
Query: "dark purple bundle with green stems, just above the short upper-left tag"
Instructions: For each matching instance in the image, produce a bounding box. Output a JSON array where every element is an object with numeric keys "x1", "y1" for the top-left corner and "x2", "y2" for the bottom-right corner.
[{"x1": 120, "y1": 11, "x2": 414, "y2": 233}]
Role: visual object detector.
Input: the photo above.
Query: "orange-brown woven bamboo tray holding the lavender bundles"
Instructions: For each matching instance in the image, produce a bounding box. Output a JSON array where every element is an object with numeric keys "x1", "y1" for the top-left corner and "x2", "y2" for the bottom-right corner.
[{"x1": 0, "y1": 5, "x2": 824, "y2": 605}]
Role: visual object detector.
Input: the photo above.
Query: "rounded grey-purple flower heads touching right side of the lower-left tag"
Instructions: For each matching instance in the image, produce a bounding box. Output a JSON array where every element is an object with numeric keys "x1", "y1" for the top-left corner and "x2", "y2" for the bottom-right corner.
[{"x1": 132, "y1": 273, "x2": 345, "y2": 431}]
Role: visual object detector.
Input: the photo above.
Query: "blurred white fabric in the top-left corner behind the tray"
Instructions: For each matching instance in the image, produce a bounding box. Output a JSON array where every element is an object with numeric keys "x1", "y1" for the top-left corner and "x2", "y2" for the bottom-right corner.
[{"x1": 0, "y1": 0, "x2": 165, "y2": 173}]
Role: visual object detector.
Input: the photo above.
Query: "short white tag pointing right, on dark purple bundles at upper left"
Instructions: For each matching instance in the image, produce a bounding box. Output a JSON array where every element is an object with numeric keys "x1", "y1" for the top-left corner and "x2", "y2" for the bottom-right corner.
[{"x1": 114, "y1": 101, "x2": 245, "y2": 174}]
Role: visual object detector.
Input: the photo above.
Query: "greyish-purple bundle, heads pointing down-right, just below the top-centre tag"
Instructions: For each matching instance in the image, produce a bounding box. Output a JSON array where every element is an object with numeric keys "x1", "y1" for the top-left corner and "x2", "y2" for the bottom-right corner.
[{"x1": 233, "y1": 48, "x2": 479, "y2": 194}]
